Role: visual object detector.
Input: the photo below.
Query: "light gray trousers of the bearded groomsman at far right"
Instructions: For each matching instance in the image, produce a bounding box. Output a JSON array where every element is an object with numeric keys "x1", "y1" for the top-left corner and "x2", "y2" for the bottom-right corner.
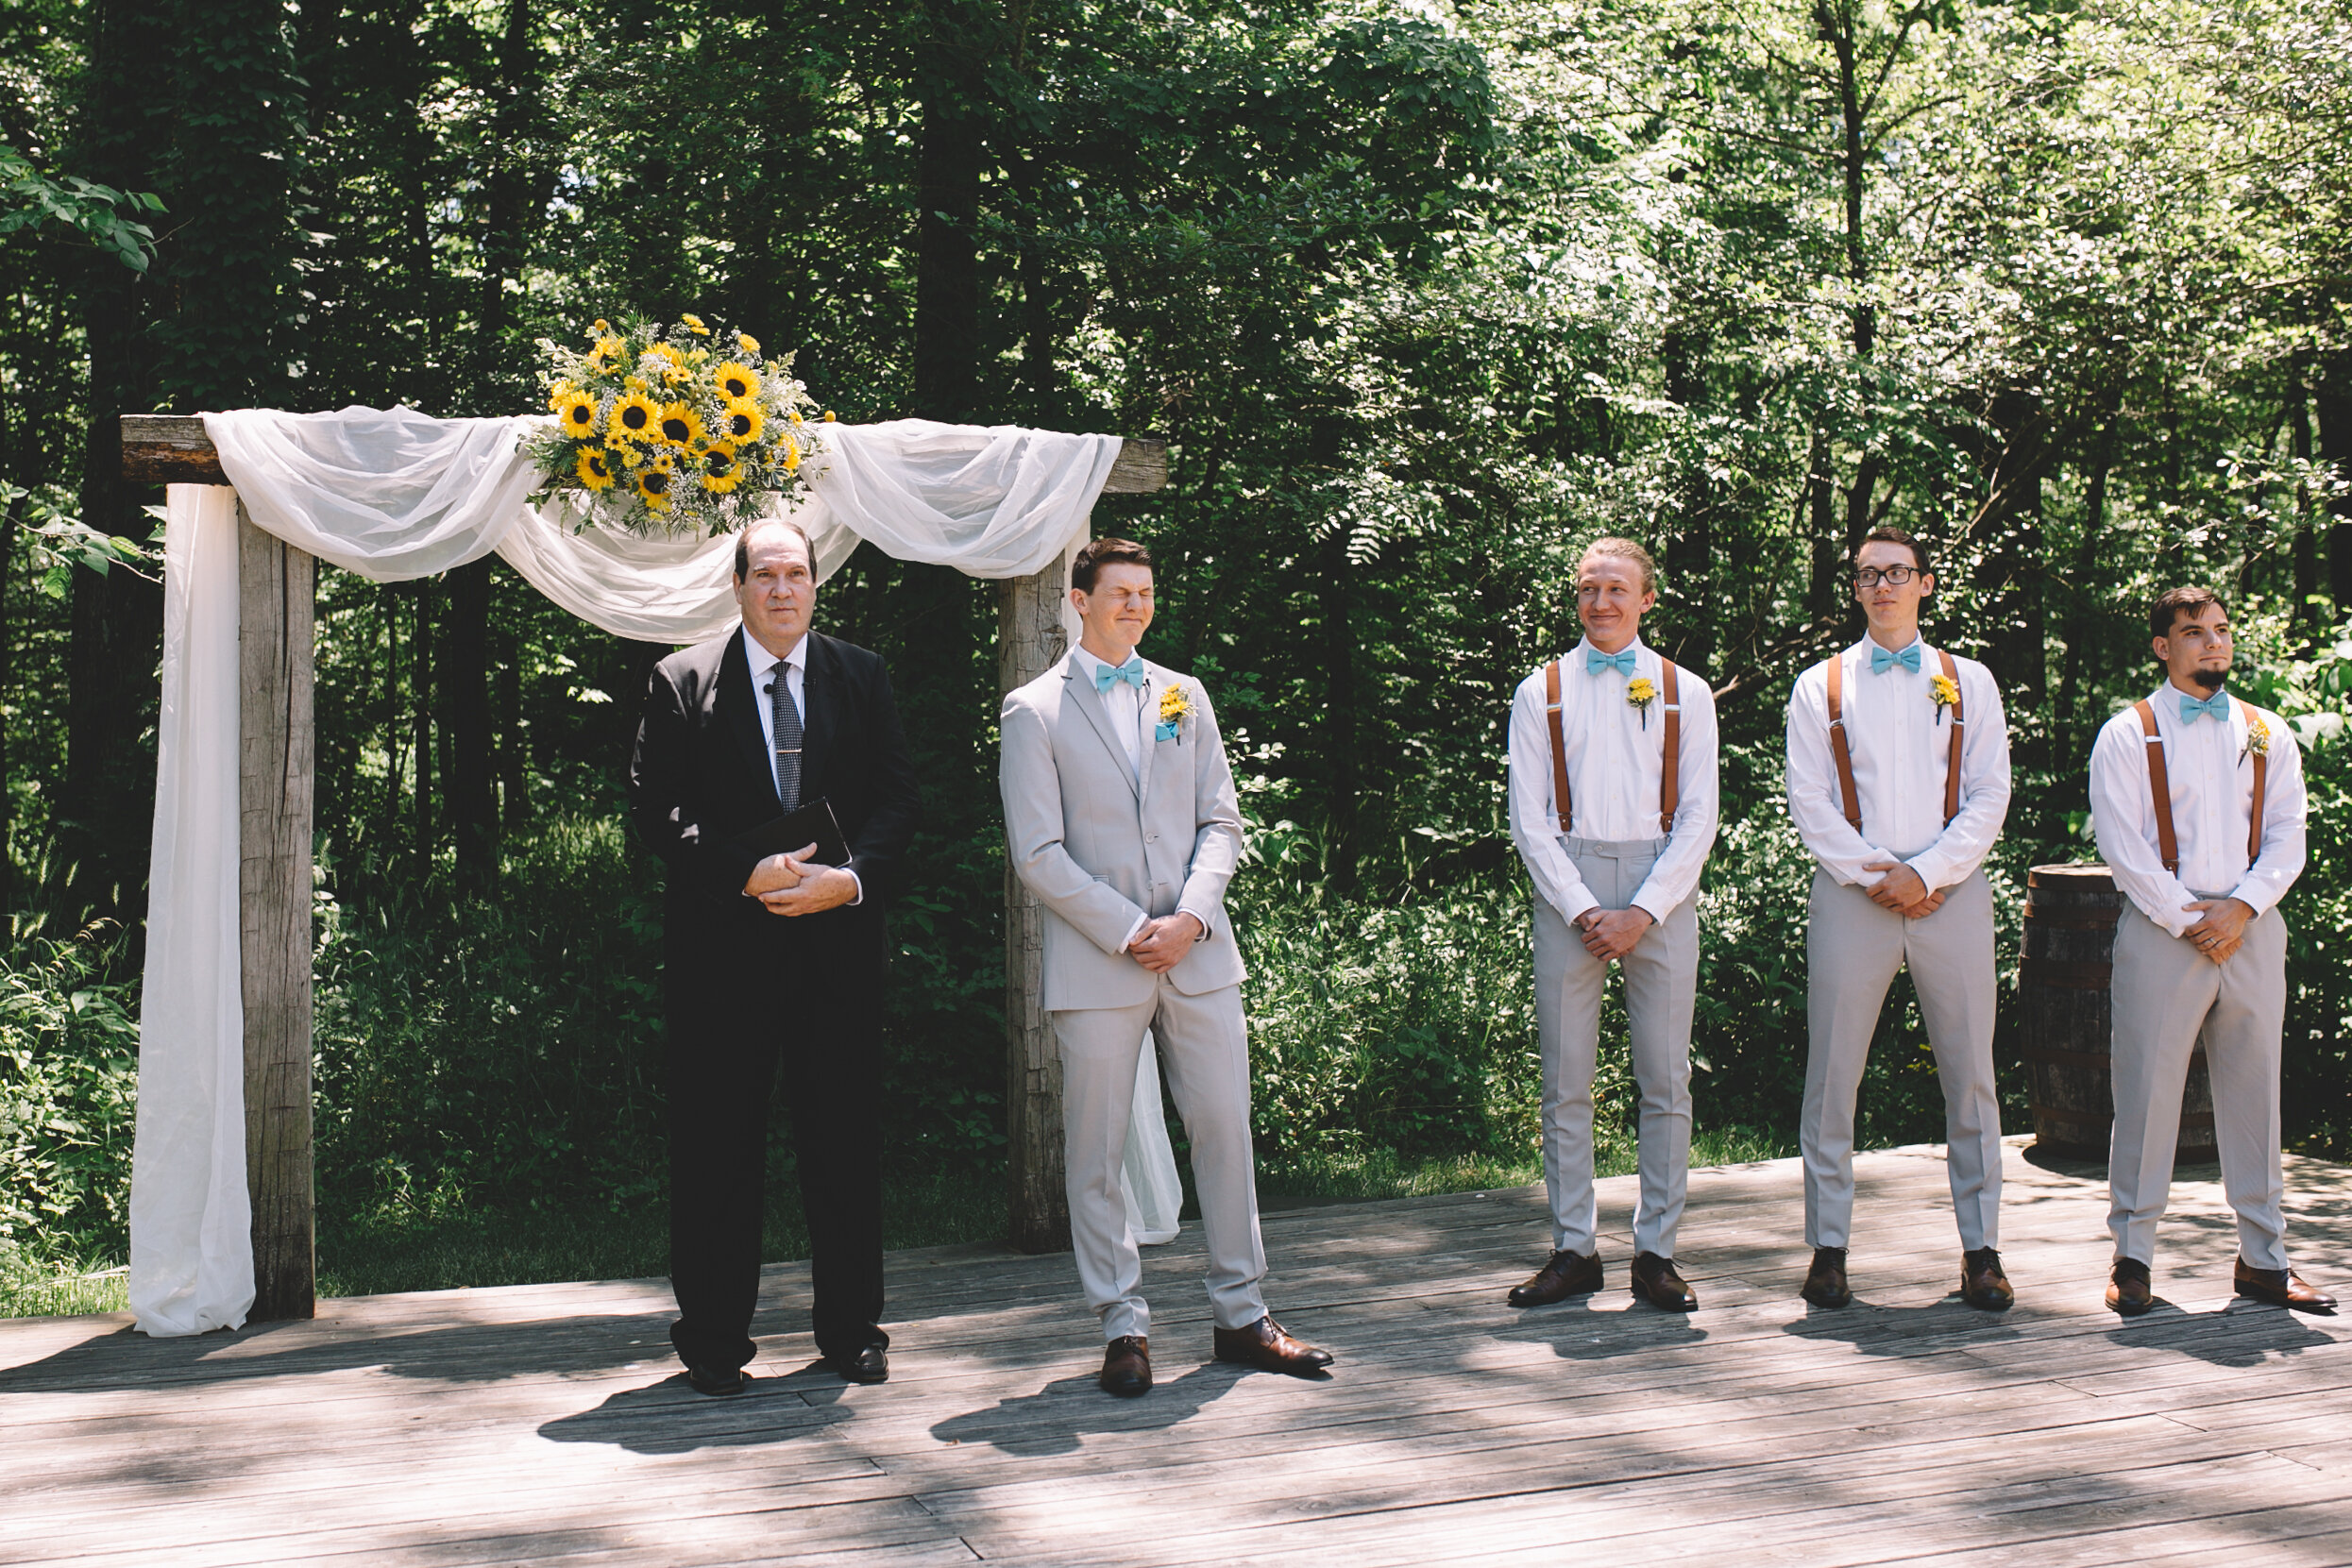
[{"x1": 2107, "y1": 893, "x2": 2286, "y2": 1270}]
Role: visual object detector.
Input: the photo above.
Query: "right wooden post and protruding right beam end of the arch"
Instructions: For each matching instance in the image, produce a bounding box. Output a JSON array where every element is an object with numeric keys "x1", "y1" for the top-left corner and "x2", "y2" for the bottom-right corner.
[{"x1": 997, "y1": 437, "x2": 1169, "y2": 1253}]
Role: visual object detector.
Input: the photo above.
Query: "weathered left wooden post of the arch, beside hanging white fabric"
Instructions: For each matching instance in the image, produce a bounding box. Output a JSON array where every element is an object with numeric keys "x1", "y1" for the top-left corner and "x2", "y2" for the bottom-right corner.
[{"x1": 238, "y1": 500, "x2": 317, "y2": 1324}]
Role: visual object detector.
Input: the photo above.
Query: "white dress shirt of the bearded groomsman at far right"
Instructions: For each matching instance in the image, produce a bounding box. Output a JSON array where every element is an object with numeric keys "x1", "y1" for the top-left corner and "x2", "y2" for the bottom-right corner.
[{"x1": 2090, "y1": 682, "x2": 2305, "y2": 936}]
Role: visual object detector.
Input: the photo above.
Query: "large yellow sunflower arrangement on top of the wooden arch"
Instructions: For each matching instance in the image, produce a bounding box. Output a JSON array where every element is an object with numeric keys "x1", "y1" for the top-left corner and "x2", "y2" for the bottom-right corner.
[{"x1": 527, "y1": 315, "x2": 833, "y2": 533}]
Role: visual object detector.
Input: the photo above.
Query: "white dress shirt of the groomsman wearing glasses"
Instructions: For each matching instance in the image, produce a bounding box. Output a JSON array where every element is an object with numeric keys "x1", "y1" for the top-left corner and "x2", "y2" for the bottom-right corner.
[{"x1": 1787, "y1": 637, "x2": 2008, "y2": 893}]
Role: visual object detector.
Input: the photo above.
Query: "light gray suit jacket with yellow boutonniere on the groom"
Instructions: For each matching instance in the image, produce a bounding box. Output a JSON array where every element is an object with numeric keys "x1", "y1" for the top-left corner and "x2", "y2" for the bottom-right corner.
[{"x1": 997, "y1": 651, "x2": 1244, "y2": 1011}]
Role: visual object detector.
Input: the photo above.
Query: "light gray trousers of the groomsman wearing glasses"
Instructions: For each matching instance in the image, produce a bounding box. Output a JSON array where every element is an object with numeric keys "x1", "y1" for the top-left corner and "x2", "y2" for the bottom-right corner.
[{"x1": 1797, "y1": 869, "x2": 2002, "y2": 1251}]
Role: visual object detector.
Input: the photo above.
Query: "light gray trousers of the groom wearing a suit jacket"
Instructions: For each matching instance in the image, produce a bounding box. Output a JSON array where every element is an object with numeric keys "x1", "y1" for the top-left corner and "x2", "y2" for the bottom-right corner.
[{"x1": 1049, "y1": 982, "x2": 1265, "y2": 1340}]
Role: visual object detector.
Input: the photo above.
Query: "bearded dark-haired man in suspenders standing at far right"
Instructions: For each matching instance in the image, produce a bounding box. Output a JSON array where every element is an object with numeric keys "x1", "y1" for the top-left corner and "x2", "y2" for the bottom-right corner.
[{"x1": 2090, "y1": 588, "x2": 2336, "y2": 1317}]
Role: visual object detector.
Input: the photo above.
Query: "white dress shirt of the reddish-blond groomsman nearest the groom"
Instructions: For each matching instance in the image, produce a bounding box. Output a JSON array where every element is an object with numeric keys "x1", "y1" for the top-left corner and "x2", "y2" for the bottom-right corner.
[{"x1": 1510, "y1": 637, "x2": 1719, "y2": 921}]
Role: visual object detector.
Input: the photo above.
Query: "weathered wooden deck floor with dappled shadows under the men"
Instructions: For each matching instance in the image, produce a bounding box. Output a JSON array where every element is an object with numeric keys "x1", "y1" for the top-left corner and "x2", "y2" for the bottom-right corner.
[{"x1": 0, "y1": 1147, "x2": 2352, "y2": 1568}]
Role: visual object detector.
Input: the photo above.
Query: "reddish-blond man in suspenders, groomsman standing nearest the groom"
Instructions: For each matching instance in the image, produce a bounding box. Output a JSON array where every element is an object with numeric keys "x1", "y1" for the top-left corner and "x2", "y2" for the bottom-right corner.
[{"x1": 1510, "y1": 538, "x2": 1717, "y2": 1312}]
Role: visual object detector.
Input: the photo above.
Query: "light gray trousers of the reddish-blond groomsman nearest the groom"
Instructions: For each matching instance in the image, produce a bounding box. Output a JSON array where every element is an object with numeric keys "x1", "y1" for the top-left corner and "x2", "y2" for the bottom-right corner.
[{"x1": 1536, "y1": 839, "x2": 1699, "y2": 1257}]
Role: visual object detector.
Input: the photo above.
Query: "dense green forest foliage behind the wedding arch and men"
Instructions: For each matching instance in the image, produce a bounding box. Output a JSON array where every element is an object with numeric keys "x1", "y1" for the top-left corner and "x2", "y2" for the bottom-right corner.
[{"x1": 0, "y1": 0, "x2": 2352, "y2": 1297}]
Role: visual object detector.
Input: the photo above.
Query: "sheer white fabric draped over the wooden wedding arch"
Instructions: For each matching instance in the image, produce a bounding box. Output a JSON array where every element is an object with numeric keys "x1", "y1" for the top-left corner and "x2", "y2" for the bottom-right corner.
[{"x1": 129, "y1": 409, "x2": 1180, "y2": 1335}]
